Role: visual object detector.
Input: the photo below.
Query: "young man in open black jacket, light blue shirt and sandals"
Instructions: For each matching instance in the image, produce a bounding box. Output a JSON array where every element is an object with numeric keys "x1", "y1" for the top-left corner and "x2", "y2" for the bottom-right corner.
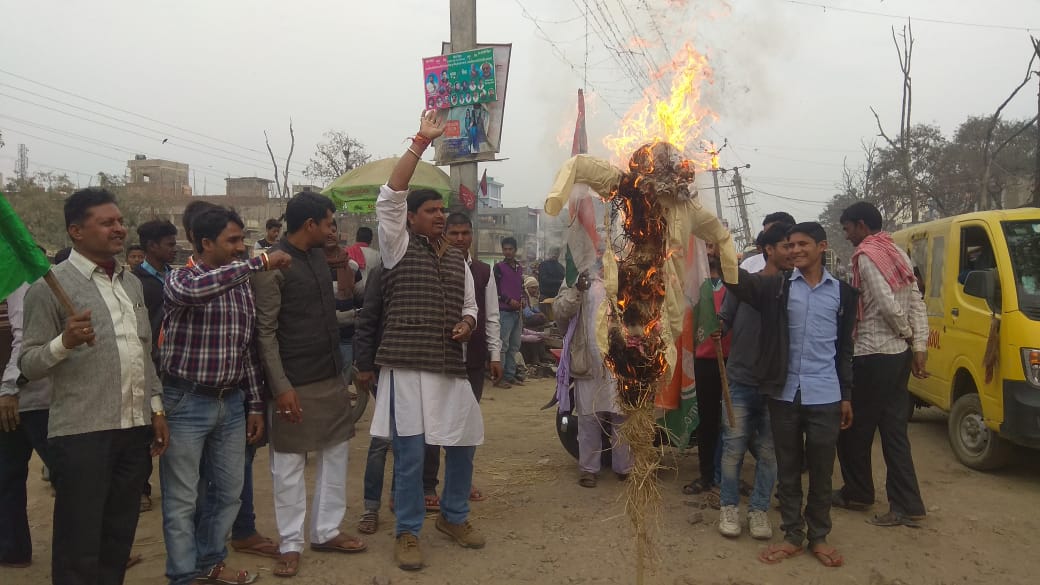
[{"x1": 728, "y1": 222, "x2": 858, "y2": 566}]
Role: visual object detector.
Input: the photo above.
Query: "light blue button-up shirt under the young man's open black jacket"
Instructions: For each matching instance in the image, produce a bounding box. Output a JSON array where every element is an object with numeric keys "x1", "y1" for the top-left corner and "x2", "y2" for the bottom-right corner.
[{"x1": 780, "y1": 269, "x2": 841, "y2": 404}]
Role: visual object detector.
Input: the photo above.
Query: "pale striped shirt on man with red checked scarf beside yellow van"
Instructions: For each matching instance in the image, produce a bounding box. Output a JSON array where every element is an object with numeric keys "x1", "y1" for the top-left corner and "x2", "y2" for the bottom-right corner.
[{"x1": 855, "y1": 250, "x2": 928, "y2": 356}]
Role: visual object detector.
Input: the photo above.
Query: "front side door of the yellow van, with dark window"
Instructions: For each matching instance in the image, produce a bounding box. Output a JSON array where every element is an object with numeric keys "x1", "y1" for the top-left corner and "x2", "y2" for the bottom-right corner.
[{"x1": 945, "y1": 220, "x2": 999, "y2": 412}]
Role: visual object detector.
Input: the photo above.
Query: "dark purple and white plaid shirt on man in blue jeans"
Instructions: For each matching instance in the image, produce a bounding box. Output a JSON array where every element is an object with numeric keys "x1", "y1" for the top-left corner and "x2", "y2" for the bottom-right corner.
[{"x1": 159, "y1": 256, "x2": 263, "y2": 414}]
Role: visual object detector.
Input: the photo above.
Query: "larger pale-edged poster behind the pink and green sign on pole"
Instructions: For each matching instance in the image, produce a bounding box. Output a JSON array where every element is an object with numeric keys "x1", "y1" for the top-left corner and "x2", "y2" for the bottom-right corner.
[{"x1": 424, "y1": 43, "x2": 513, "y2": 164}]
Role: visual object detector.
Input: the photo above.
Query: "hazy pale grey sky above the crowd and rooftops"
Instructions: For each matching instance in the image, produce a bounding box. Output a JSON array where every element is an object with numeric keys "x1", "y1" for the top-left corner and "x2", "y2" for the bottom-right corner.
[{"x1": 0, "y1": 0, "x2": 1040, "y2": 229}]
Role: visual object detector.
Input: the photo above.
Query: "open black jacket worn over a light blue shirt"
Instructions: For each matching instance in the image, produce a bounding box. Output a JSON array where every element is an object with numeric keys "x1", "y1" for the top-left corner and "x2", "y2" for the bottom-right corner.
[{"x1": 726, "y1": 270, "x2": 859, "y2": 401}]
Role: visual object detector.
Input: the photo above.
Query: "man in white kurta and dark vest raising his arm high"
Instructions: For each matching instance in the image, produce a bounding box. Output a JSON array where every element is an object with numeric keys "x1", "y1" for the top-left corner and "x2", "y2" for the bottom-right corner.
[{"x1": 371, "y1": 110, "x2": 485, "y2": 570}]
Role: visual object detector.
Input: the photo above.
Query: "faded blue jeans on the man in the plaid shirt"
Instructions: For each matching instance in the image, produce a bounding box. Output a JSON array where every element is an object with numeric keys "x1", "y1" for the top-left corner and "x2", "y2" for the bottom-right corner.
[{"x1": 159, "y1": 386, "x2": 245, "y2": 585}]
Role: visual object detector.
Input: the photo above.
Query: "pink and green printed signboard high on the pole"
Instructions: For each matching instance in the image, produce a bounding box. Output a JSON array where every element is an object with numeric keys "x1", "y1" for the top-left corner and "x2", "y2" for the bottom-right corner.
[{"x1": 422, "y1": 47, "x2": 498, "y2": 109}]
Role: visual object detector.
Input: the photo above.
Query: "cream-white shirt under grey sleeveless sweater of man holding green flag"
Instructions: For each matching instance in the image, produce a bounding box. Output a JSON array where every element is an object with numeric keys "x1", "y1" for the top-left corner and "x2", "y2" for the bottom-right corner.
[{"x1": 50, "y1": 250, "x2": 162, "y2": 429}]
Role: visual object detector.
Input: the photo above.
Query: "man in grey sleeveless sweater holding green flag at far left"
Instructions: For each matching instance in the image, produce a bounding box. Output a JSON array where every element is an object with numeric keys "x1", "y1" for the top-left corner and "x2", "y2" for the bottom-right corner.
[{"x1": 15, "y1": 188, "x2": 168, "y2": 585}]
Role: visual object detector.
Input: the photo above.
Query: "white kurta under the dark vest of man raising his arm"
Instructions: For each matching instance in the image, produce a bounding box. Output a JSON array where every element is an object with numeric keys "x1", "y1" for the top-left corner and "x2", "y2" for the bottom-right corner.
[{"x1": 370, "y1": 185, "x2": 484, "y2": 446}]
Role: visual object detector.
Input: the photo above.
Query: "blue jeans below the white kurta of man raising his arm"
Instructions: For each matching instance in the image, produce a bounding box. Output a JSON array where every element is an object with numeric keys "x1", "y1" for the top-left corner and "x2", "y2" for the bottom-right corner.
[{"x1": 390, "y1": 377, "x2": 476, "y2": 536}]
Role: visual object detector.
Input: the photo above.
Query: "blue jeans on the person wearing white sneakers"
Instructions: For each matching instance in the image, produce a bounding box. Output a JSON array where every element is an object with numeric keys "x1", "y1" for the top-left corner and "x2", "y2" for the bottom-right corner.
[{"x1": 720, "y1": 382, "x2": 777, "y2": 511}]
